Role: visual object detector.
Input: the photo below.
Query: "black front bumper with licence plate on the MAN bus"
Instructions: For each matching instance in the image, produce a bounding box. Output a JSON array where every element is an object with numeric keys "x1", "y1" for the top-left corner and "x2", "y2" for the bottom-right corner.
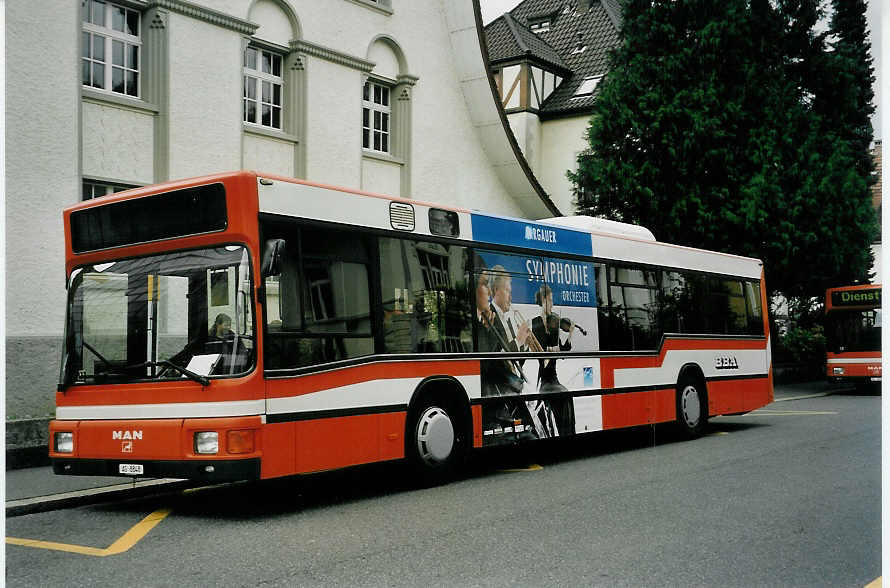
[{"x1": 52, "y1": 457, "x2": 260, "y2": 482}]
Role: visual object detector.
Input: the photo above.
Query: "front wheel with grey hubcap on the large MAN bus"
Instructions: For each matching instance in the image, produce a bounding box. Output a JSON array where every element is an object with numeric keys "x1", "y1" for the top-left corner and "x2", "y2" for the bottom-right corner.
[{"x1": 405, "y1": 400, "x2": 466, "y2": 485}]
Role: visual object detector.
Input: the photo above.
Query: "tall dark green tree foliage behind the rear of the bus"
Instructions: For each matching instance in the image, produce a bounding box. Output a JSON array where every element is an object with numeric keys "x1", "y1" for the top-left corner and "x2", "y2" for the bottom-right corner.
[{"x1": 569, "y1": 0, "x2": 876, "y2": 296}]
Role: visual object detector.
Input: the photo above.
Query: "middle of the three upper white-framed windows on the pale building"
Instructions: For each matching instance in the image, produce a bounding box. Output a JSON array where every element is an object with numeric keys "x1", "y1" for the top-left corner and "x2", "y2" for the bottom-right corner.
[{"x1": 244, "y1": 47, "x2": 284, "y2": 130}]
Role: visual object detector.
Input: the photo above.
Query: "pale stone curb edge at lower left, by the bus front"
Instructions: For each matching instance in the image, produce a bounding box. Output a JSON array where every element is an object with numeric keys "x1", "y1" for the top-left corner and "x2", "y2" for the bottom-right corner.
[{"x1": 6, "y1": 478, "x2": 194, "y2": 518}]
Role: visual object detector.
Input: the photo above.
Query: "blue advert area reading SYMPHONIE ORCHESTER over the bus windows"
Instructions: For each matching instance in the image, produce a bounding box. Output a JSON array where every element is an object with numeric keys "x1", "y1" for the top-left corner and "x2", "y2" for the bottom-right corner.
[{"x1": 476, "y1": 251, "x2": 596, "y2": 308}]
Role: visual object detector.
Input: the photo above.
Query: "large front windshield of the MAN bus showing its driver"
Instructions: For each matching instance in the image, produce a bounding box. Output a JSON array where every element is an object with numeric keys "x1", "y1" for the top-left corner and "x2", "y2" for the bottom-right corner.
[{"x1": 60, "y1": 245, "x2": 256, "y2": 388}]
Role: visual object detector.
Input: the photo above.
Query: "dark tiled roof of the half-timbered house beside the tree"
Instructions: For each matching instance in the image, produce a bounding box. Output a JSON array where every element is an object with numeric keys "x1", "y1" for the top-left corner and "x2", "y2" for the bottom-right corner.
[{"x1": 485, "y1": 0, "x2": 622, "y2": 115}]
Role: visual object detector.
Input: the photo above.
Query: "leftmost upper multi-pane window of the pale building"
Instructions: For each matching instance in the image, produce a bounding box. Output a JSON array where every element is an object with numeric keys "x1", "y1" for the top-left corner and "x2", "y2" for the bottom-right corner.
[{"x1": 81, "y1": 0, "x2": 142, "y2": 98}]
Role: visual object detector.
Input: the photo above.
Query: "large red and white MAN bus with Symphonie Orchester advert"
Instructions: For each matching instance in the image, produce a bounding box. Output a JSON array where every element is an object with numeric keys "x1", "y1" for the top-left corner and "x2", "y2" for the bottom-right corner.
[{"x1": 50, "y1": 171, "x2": 773, "y2": 480}]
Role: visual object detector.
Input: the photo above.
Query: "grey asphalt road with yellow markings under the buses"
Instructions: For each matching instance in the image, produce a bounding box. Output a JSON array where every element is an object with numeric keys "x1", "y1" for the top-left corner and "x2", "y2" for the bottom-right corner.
[{"x1": 6, "y1": 386, "x2": 881, "y2": 587}]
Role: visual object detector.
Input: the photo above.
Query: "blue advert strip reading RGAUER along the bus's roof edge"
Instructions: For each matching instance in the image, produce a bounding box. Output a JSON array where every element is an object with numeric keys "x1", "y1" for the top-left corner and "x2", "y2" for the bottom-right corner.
[{"x1": 470, "y1": 213, "x2": 593, "y2": 255}]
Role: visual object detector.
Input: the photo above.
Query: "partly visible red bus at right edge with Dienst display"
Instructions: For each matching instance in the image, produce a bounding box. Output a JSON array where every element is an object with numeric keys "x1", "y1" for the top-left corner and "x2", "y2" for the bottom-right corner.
[{"x1": 825, "y1": 284, "x2": 881, "y2": 387}]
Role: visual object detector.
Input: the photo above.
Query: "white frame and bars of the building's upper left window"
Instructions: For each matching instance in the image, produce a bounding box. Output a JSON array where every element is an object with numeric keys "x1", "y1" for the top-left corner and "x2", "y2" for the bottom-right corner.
[{"x1": 80, "y1": 0, "x2": 144, "y2": 100}]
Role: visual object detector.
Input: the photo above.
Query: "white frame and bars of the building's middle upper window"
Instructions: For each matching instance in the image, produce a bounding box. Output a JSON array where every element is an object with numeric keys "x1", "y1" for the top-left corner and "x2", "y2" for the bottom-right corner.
[{"x1": 241, "y1": 43, "x2": 286, "y2": 132}]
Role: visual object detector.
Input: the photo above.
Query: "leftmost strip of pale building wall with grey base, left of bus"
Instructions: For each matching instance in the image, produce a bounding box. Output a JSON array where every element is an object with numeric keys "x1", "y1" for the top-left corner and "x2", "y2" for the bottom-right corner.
[{"x1": 4, "y1": 0, "x2": 81, "y2": 418}]
